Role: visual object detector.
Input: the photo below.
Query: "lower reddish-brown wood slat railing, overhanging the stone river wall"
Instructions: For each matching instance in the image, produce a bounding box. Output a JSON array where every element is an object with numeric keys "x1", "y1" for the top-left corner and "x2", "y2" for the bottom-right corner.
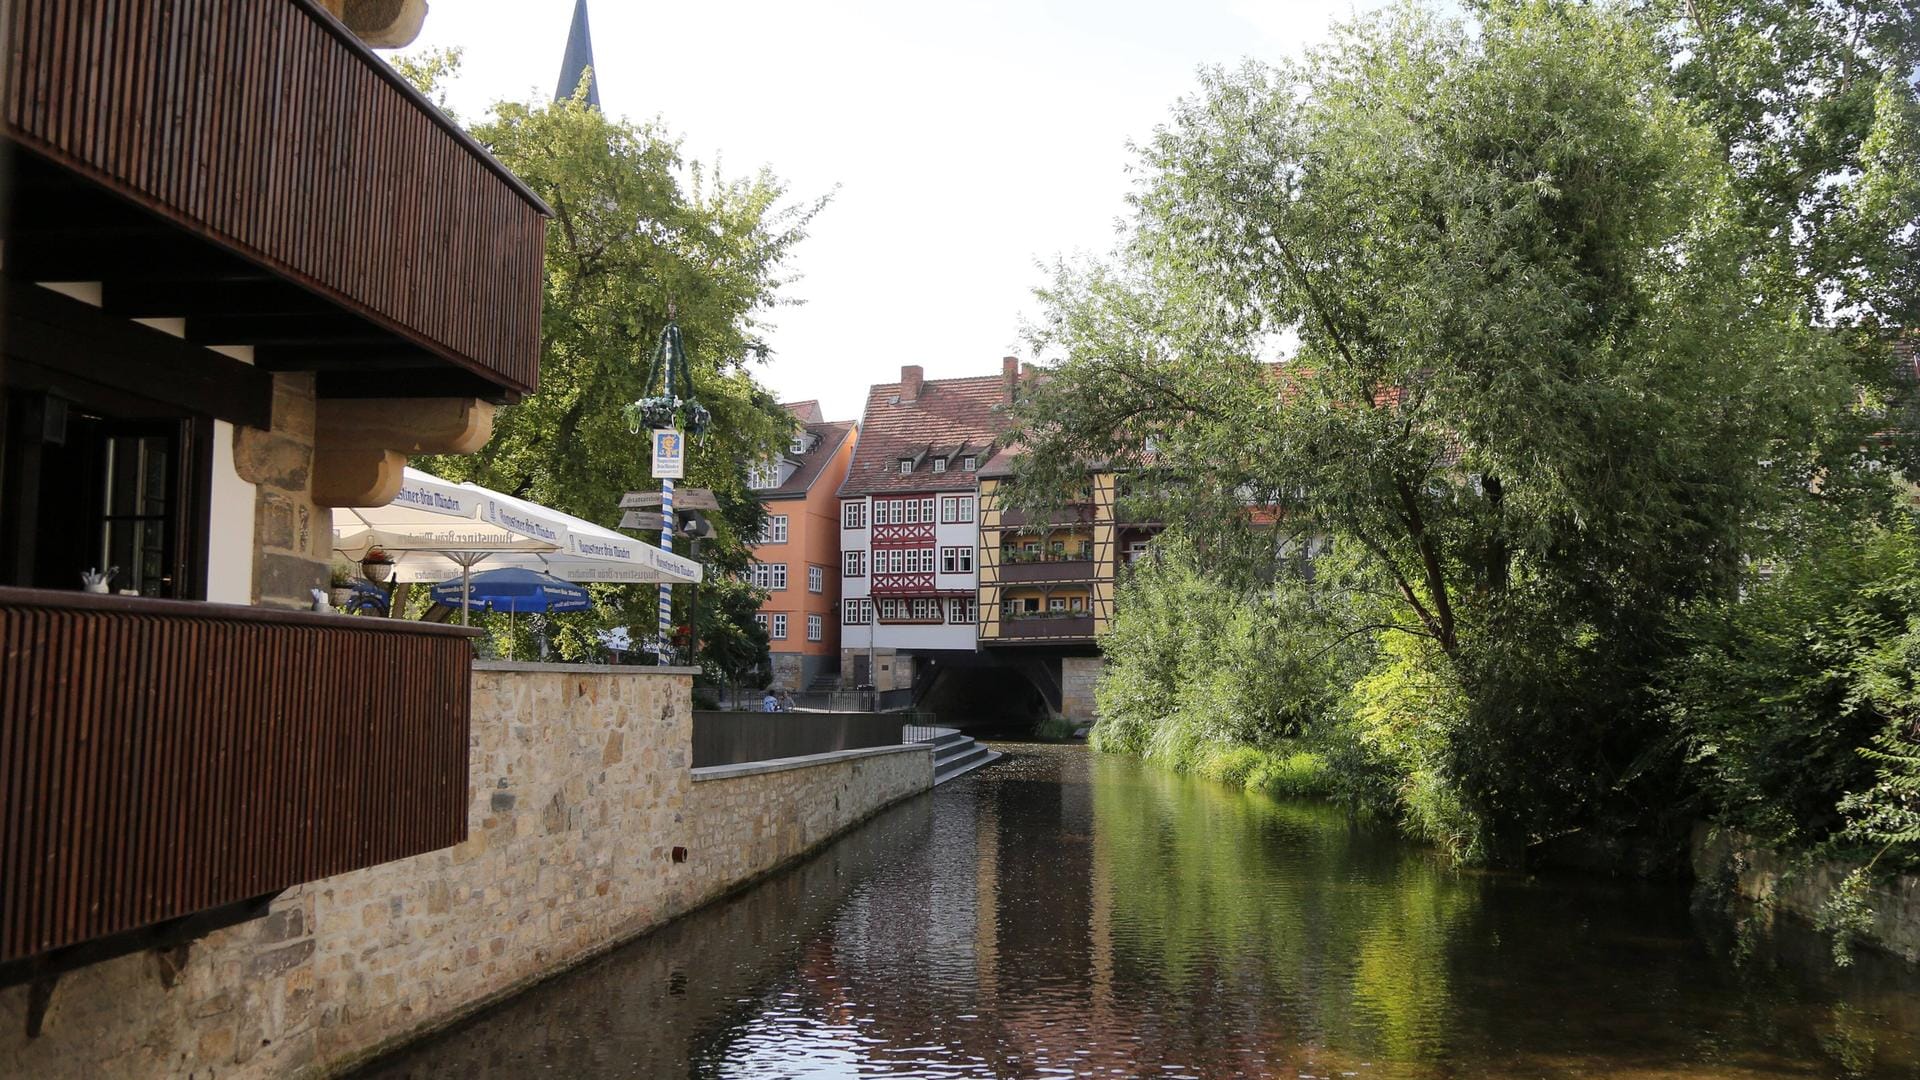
[{"x1": 0, "y1": 588, "x2": 472, "y2": 963}]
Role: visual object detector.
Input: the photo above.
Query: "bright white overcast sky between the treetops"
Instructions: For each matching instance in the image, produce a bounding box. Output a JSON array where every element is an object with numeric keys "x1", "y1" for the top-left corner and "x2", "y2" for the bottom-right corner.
[{"x1": 407, "y1": 0, "x2": 1367, "y2": 419}]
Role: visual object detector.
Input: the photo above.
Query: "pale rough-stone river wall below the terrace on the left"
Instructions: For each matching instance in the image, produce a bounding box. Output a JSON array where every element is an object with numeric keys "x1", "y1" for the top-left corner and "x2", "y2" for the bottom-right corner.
[{"x1": 0, "y1": 665, "x2": 931, "y2": 1080}]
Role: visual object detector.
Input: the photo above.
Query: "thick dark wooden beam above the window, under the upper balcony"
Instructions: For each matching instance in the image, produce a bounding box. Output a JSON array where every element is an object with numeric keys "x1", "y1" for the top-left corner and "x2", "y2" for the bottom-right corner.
[{"x1": 0, "y1": 275, "x2": 273, "y2": 429}]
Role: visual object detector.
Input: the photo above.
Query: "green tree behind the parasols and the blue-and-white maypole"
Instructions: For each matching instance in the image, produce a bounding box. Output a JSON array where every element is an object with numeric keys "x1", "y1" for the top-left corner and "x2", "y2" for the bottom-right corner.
[{"x1": 397, "y1": 52, "x2": 826, "y2": 653}]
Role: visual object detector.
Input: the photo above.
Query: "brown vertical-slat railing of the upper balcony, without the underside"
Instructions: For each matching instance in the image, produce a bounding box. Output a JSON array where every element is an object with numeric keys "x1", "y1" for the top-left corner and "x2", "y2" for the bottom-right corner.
[{"x1": 0, "y1": 0, "x2": 545, "y2": 392}]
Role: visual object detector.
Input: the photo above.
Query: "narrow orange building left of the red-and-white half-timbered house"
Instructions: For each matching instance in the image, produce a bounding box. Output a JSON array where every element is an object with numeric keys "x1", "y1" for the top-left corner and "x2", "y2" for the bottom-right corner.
[{"x1": 751, "y1": 402, "x2": 858, "y2": 690}]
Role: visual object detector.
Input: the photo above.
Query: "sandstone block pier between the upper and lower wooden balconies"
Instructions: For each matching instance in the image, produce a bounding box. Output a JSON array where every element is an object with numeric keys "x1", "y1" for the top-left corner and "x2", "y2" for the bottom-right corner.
[{"x1": 234, "y1": 373, "x2": 334, "y2": 609}]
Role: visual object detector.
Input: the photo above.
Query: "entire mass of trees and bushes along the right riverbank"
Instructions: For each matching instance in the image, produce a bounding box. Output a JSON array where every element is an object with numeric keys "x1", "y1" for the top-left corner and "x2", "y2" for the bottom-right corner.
[{"x1": 1012, "y1": 0, "x2": 1920, "y2": 867}]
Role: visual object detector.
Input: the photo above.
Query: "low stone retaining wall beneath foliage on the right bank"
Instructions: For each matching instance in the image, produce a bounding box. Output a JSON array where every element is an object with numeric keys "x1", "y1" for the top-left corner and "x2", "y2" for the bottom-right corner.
[{"x1": 1693, "y1": 822, "x2": 1920, "y2": 963}]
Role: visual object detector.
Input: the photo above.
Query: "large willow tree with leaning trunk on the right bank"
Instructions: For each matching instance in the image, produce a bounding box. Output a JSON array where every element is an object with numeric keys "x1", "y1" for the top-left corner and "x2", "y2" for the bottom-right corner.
[{"x1": 1016, "y1": 4, "x2": 1896, "y2": 859}]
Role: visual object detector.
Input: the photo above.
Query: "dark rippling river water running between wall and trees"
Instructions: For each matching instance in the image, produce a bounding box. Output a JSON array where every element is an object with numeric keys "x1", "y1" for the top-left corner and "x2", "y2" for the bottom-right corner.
[{"x1": 369, "y1": 746, "x2": 1920, "y2": 1080}]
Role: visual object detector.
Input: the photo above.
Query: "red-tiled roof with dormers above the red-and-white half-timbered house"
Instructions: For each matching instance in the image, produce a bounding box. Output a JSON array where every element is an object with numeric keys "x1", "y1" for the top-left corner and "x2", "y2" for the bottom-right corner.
[{"x1": 841, "y1": 365, "x2": 1008, "y2": 496}]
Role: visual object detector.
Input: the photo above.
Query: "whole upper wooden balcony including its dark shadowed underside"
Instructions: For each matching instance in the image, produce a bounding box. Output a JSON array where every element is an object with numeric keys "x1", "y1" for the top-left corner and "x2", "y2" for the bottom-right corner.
[{"x1": 0, "y1": 0, "x2": 547, "y2": 400}]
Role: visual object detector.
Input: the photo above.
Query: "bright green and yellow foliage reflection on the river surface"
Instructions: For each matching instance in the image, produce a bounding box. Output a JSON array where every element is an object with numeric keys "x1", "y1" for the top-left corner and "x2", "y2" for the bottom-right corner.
[{"x1": 1092, "y1": 757, "x2": 1478, "y2": 1061}]
